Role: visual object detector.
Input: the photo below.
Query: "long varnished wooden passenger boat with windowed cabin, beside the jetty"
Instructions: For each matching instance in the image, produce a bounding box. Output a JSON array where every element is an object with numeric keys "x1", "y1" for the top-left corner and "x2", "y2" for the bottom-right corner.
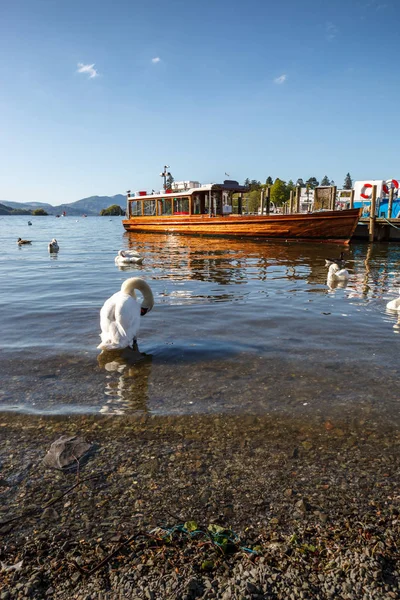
[{"x1": 122, "y1": 181, "x2": 360, "y2": 244}]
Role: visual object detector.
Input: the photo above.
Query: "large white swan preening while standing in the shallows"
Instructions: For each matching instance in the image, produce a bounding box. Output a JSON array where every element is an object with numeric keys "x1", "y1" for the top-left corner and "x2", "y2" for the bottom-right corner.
[{"x1": 97, "y1": 277, "x2": 154, "y2": 350}]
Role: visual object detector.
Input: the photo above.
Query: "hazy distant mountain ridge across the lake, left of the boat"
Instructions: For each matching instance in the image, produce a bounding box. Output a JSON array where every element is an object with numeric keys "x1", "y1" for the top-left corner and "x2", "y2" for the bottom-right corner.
[{"x1": 0, "y1": 194, "x2": 126, "y2": 216}]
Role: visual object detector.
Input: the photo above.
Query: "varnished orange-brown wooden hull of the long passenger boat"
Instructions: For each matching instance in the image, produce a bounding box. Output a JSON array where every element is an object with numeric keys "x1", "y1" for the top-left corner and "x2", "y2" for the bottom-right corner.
[{"x1": 122, "y1": 209, "x2": 360, "y2": 244}]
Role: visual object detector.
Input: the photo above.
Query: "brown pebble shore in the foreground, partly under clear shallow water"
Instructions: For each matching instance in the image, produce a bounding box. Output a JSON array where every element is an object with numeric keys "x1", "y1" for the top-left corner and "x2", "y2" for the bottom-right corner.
[{"x1": 0, "y1": 413, "x2": 400, "y2": 600}]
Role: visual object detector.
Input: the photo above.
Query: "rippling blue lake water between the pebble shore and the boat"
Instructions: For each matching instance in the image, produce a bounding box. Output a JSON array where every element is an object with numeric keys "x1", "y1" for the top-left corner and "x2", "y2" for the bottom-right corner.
[{"x1": 0, "y1": 216, "x2": 400, "y2": 422}]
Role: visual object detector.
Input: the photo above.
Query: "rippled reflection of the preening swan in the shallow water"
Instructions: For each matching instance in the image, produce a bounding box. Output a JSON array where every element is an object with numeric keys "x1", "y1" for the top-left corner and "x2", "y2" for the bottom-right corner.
[{"x1": 97, "y1": 345, "x2": 153, "y2": 415}]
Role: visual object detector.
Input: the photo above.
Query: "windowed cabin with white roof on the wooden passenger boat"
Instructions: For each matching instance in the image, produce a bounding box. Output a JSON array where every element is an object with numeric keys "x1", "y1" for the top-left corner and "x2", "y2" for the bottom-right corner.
[{"x1": 126, "y1": 180, "x2": 248, "y2": 219}]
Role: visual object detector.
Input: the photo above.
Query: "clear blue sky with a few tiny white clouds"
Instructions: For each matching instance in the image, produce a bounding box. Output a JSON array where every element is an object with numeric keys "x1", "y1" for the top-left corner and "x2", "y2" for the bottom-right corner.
[{"x1": 0, "y1": 0, "x2": 400, "y2": 204}]
